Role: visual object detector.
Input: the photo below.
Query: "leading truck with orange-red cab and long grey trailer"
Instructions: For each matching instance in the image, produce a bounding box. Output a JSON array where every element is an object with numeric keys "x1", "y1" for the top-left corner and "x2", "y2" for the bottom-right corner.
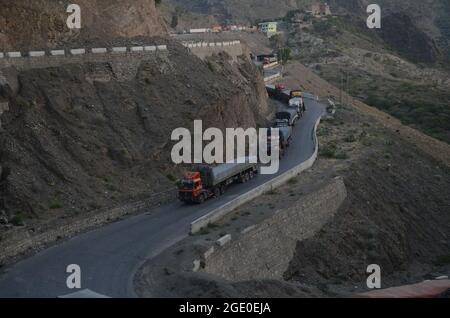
[{"x1": 178, "y1": 158, "x2": 258, "y2": 203}]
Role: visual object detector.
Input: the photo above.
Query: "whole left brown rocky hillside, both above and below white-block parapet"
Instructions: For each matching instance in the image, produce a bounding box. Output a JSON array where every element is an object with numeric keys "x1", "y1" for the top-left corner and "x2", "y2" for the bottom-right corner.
[{"x1": 0, "y1": 0, "x2": 268, "y2": 238}]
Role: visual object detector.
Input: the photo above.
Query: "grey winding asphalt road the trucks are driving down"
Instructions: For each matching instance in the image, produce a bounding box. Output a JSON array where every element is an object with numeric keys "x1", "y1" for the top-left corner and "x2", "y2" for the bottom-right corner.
[{"x1": 0, "y1": 96, "x2": 324, "y2": 298}]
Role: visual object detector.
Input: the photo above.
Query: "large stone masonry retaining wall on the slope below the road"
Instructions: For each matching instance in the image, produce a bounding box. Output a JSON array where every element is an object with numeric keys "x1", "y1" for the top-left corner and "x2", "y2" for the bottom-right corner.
[{"x1": 203, "y1": 178, "x2": 347, "y2": 282}]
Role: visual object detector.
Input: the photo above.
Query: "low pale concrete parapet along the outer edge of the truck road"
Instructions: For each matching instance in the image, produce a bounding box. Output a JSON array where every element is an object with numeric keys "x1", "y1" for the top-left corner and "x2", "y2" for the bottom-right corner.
[{"x1": 191, "y1": 118, "x2": 320, "y2": 234}]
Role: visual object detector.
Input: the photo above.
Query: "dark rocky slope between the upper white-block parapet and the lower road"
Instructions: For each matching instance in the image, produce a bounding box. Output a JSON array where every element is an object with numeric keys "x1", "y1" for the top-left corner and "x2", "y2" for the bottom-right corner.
[{"x1": 0, "y1": 39, "x2": 267, "y2": 227}]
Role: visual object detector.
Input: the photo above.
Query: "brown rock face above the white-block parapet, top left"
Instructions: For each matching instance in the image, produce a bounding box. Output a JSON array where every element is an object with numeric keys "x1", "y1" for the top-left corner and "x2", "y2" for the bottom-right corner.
[{"x1": 0, "y1": 0, "x2": 166, "y2": 50}]
